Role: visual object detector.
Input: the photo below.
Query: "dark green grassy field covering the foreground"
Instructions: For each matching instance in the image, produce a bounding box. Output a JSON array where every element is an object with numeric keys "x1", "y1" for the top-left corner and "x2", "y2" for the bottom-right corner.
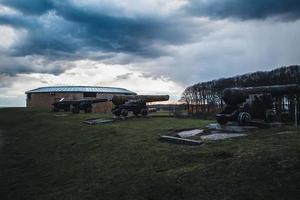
[{"x1": 0, "y1": 108, "x2": 300, "y2": 200}]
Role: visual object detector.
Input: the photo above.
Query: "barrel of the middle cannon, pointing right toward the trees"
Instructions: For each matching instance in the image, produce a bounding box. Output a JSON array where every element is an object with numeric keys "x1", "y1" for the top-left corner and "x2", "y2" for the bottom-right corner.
[{"x1": 112, "y1": 95, "x2": 169, "y2": 105}]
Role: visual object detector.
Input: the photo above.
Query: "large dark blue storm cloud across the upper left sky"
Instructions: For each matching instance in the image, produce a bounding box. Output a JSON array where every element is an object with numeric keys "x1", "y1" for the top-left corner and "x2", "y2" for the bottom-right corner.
[{"x1": 0, "y1": 0, "x2": 189, "y2": 57}]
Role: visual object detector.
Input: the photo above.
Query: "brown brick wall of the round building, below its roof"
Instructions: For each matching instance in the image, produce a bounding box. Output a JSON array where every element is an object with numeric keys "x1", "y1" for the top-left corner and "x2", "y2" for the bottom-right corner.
[{"x1": 26, "y1": 93, "x2": 113, "y2": 113}]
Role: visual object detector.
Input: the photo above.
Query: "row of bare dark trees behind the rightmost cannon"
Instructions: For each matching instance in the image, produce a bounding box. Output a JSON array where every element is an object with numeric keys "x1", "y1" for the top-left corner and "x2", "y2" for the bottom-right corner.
[{"x1": 181, "y1": 65, "x2": 300, "y2": 113}]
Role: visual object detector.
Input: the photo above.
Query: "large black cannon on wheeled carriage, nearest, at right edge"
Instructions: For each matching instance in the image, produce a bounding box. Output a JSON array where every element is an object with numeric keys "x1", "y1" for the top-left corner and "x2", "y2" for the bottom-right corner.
[{"x1": 216, "y1": 84, "x2": 300, "y2": 125}]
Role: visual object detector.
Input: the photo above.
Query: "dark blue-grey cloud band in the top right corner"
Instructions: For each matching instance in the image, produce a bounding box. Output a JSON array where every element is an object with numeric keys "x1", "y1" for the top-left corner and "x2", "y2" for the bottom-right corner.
[{"x1": 185, "y1": 0, "x2": 300, "y2": 20}]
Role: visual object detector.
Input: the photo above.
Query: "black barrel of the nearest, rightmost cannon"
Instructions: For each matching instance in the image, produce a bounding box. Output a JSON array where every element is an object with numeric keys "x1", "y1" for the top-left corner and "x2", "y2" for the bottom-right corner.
[{"x1": 222, "y1": 84, "x2": 300, "y2": 105}]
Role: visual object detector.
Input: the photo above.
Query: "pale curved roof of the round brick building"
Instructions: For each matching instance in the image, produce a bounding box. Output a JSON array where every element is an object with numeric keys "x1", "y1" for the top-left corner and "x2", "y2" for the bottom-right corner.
[{"x1": 25, "y1": 86, "x2": 136, "y2": 95}]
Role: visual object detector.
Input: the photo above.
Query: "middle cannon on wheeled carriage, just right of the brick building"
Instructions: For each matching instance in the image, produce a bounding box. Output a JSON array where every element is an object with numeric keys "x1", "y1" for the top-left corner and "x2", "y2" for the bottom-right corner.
[{"x1": 112, "y1": 95, "x2": 169, "y2": 117}]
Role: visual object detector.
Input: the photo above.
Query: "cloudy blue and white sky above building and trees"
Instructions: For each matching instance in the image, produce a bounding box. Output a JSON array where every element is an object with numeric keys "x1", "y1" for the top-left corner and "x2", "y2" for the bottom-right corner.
[{"x1": 0, "y1": 0, "x2": 300, "y2": 107}]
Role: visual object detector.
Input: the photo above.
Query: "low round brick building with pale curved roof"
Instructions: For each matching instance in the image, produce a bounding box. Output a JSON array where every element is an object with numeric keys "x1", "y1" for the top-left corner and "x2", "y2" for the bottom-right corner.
[{"x1": 25, "y1": 86, "x2": 136, "y2": 113}]
